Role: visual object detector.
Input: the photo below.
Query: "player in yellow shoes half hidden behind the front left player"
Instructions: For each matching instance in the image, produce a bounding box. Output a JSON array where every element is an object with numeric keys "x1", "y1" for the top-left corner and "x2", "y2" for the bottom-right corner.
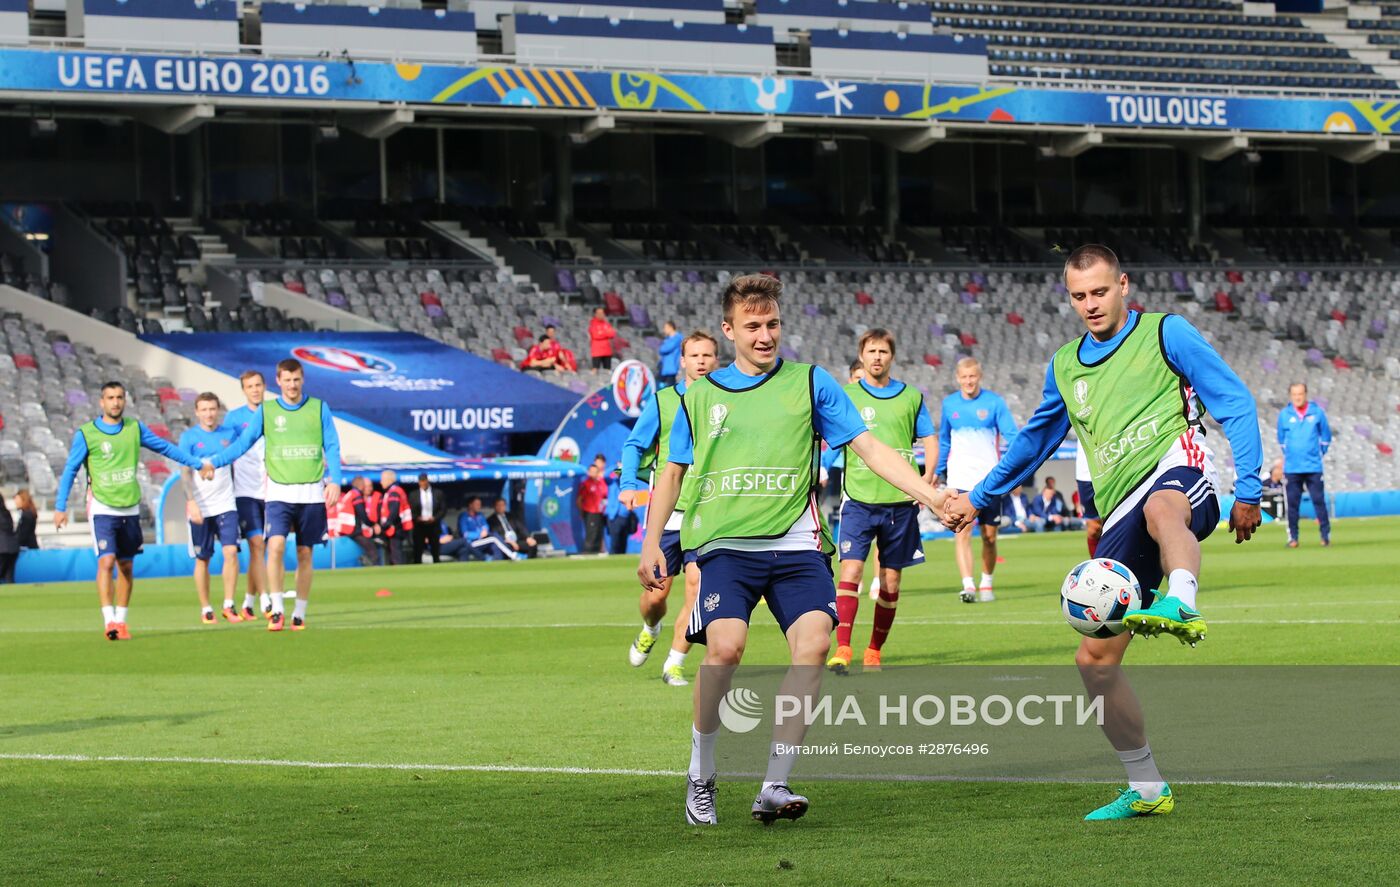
[{"x1": 617, "y1": 330, "x2": 720, "y2": 687}]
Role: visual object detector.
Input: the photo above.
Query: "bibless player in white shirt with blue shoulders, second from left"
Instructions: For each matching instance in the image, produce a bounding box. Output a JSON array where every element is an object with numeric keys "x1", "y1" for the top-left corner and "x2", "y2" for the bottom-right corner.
[{"x1": 179, "y1": 392, "x2": 246, "y2": 625}]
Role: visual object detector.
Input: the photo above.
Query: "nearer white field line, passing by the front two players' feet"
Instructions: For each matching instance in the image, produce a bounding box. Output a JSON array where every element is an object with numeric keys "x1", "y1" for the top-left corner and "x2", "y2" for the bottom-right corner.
[{"x1": 0, "y1": 753, "x2": 1400, "y2": 792}]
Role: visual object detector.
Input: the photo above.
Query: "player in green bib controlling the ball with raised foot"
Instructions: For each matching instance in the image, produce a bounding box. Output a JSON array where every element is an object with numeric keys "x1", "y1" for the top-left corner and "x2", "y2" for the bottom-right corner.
[{"x1": 944, "y1": 245, "x2": 1263, "y2": 820}]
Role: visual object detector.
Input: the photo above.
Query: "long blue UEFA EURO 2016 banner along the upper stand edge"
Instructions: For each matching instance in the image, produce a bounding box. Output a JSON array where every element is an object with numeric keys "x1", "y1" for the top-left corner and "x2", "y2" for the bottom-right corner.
[{"x1": 0, "y1": 49, "x2": 1400, "y2": 133}]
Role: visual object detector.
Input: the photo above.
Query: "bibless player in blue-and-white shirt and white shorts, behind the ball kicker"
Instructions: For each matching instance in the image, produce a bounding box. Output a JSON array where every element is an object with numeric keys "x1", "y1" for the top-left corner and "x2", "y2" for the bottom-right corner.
[{"x1": 938, "y1": 357, "x2": 1016, "y2": 603}]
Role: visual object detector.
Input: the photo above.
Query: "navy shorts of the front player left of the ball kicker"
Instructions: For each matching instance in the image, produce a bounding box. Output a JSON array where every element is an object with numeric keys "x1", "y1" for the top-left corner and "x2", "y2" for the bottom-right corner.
[{"x1": 686, "y1": 550, "x2": 836, "y2": 644}]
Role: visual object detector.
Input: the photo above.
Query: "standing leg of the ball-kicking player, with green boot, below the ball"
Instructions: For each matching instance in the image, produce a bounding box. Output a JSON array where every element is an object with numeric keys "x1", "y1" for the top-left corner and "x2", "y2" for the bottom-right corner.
[{"x1": 1074, "y1": 634, "x2": 1176, "y2": 820}]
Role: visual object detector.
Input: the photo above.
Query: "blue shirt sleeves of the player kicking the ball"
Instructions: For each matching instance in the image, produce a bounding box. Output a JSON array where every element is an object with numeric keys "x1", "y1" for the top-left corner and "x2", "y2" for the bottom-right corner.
[{"x1": 967, "y1": 311, "x2": 1264, "y2": 508}]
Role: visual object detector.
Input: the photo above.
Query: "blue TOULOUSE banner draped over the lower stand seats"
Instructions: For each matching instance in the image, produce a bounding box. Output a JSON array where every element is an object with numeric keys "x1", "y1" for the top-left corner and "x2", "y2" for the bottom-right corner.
[{"x1": 141, "y1": 333, "x2": 577, "y2": 452}]
